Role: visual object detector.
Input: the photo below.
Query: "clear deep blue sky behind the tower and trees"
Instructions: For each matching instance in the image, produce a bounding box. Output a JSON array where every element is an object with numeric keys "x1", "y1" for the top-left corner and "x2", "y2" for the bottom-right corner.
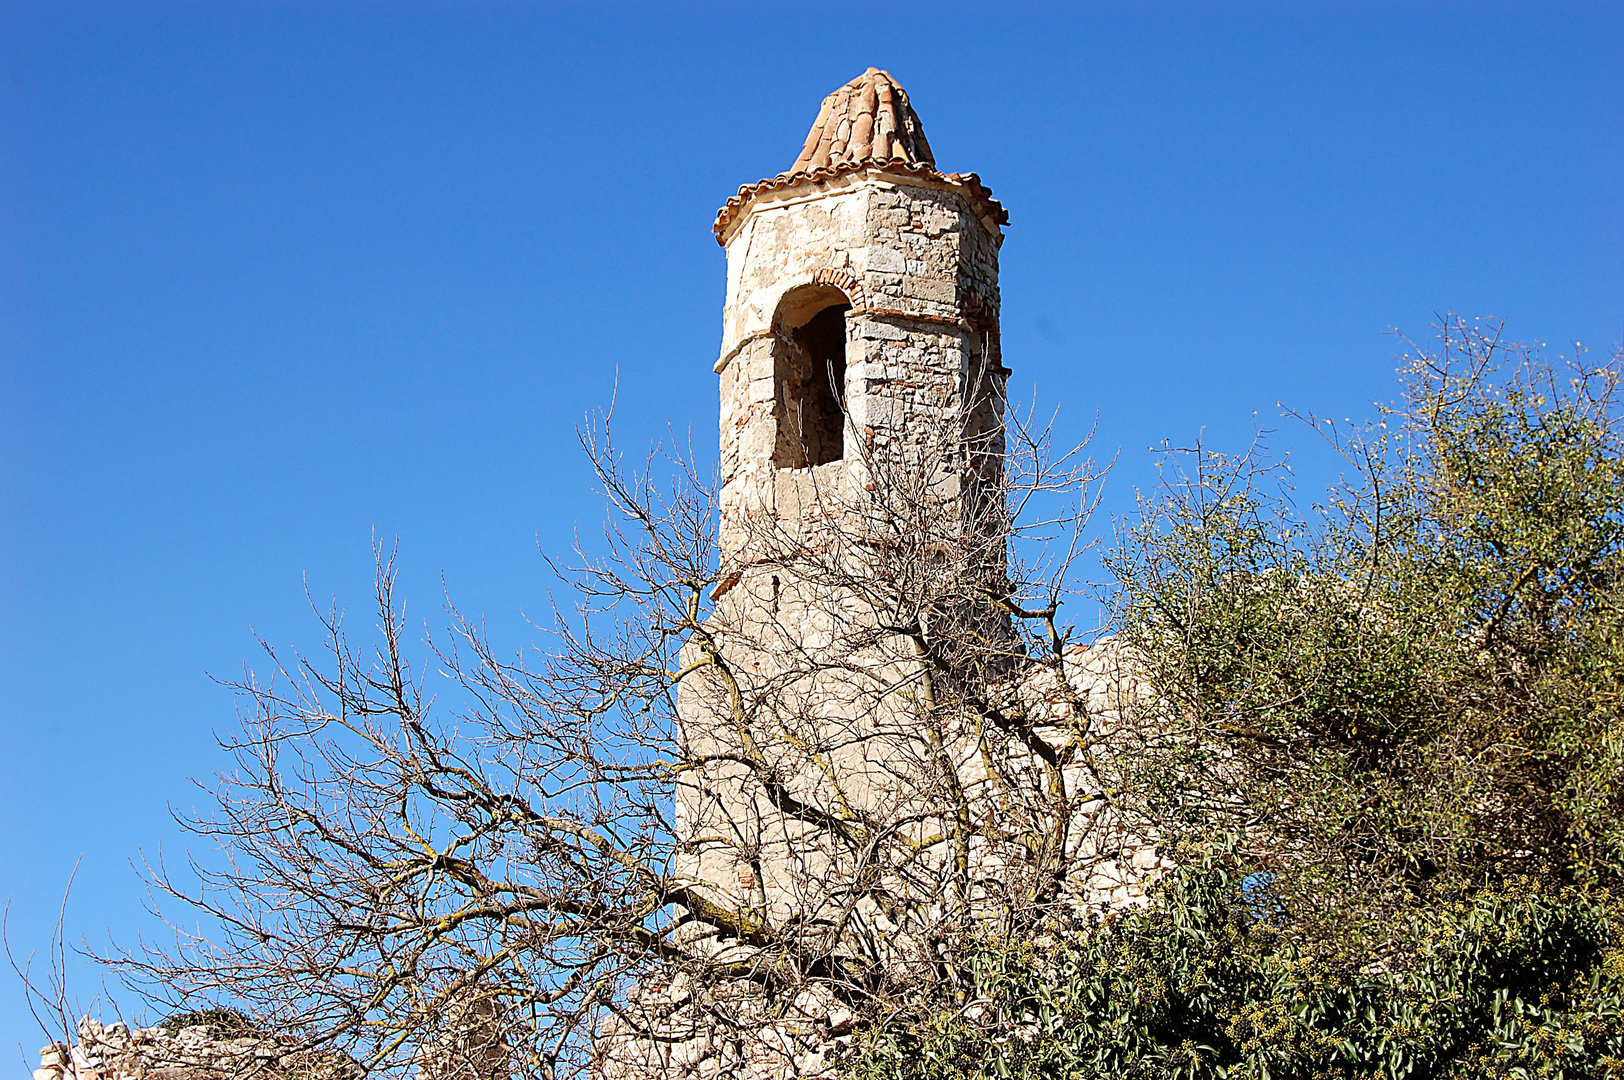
[{"x1": 0, "y1": 2, "x2": 1624, "y2": 1045}]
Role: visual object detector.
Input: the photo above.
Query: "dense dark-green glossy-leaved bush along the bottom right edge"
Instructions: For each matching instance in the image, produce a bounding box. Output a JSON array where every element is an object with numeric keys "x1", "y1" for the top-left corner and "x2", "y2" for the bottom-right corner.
[{"x1": 848, "y1": 858, "x2": 1624, "y2": 1080}]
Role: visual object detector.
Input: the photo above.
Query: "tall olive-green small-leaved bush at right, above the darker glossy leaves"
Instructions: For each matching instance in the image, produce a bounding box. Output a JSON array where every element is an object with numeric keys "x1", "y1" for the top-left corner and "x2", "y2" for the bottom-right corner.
[{"x1": 1112, "y1": 323, "x2": 1624, "y2": 948}]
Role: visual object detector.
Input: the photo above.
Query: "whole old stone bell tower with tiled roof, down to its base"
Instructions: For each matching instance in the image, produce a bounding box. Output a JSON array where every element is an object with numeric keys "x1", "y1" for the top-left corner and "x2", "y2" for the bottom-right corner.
[{"x1": 607, "y1": 68, "x2": 1007, "y2": 1080}]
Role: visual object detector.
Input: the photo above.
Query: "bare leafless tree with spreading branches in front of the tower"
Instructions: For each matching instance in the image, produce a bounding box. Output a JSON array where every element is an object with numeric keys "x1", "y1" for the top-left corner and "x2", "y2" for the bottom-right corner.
[{"x1": 107, "y1": 397, "x2": 1127, "y2": 1078}]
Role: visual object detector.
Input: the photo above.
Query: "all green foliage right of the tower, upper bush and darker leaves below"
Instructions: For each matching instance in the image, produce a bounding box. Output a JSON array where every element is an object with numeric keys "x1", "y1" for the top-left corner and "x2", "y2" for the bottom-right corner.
[{"x1": 848, "y1": 322, "x2": 1624, "y2": 1080}]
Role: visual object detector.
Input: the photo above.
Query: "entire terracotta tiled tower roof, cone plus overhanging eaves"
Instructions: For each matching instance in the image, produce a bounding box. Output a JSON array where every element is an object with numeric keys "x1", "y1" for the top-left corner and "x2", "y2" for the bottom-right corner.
[{"x1": 715, "y1": 68, "x2": 1010, "y2": 244}]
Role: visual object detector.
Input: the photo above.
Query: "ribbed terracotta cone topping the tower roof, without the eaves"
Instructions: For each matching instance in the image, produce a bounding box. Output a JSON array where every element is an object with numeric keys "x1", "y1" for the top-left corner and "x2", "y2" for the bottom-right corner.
[{"x1": 789, "y1": 68, "x2": 935, "y2": 172}]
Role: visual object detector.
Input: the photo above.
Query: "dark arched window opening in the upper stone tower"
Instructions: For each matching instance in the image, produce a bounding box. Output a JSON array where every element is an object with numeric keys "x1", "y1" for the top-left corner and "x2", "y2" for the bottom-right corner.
[{"x1": 773, "y1": 286, "x2": 851, "y2": 469}]
